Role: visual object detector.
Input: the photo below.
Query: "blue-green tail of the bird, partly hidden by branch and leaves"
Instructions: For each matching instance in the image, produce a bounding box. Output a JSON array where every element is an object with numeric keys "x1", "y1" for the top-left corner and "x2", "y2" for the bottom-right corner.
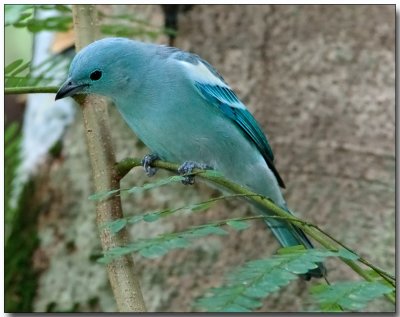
[{"x1": 265, "y1": 208, "x2": 326, "y2": 280}]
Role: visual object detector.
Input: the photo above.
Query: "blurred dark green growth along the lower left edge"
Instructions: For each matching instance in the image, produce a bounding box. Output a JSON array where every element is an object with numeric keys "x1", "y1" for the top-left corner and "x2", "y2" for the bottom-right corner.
[{"x1": 4, "y1": 123, "x2": 38, "y2": 312}]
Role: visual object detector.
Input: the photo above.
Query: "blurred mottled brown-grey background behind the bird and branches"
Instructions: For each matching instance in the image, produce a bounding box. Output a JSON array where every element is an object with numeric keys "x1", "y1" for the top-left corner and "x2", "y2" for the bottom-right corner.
[{"x1": 4, "y1": 5, "x2": 395, "y2": 312}]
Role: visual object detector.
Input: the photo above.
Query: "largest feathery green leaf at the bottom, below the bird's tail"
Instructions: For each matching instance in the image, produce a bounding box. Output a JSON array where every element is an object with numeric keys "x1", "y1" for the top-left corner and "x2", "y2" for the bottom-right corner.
[{"x1": 196, "y1": 246, "x2": 360, "y2": 312}]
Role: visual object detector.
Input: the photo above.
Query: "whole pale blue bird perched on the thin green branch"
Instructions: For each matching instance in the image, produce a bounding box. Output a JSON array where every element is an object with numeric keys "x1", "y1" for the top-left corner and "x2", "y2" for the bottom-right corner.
[{"x1": 55, "y1": 37, "x2": 326, "y2": 280}]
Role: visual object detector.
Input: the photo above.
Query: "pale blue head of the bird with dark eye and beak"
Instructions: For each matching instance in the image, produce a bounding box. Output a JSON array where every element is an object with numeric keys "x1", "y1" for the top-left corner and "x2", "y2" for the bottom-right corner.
[{"x1": 56, "y1": 38, "x2": 138, "y2": 100}]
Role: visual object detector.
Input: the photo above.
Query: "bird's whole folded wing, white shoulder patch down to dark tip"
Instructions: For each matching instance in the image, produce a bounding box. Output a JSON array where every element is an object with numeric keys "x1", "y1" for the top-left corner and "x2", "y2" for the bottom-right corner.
[{"x1": 175, "y1": 51, "x2": 285, "y2": 188}]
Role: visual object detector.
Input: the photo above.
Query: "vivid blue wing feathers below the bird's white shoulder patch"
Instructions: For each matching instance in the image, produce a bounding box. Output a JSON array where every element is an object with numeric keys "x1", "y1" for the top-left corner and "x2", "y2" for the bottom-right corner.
[{"x1": 195, "y1": 82, "x2": 285, "y2": 188}]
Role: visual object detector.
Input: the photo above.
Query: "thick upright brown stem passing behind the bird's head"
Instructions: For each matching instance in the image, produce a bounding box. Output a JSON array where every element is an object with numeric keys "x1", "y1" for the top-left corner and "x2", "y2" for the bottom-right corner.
[{"x1": 72, "y1": 5, "x2": 146, "y2": 312}]
